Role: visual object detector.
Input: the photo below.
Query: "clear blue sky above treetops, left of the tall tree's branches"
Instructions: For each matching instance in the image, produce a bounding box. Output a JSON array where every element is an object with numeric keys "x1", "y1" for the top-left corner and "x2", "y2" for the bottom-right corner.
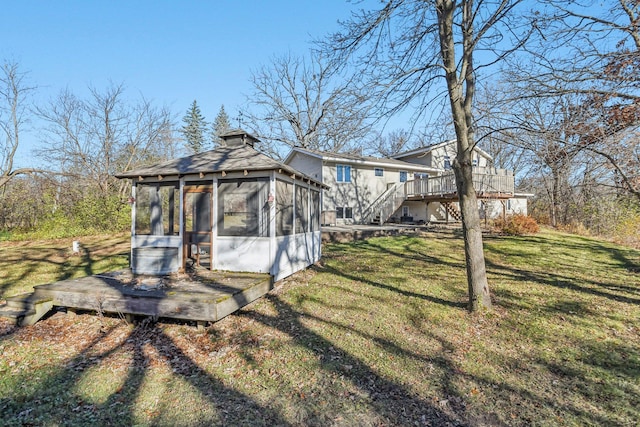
[{"x1": 0, "y1": 0, "x2": 358, "y2": 166}]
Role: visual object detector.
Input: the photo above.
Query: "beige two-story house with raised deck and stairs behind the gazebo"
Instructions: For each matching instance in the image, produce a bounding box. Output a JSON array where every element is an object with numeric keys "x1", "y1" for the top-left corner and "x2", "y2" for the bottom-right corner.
[{"x1": 285, "y1": 140, "x2": 526, "y2": 224}]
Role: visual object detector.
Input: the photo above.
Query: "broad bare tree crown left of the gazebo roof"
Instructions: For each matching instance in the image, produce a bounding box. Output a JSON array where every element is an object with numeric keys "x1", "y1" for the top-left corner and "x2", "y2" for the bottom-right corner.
[{"x1": 38, "y1": 84, "x2": 175, "y2": 196}]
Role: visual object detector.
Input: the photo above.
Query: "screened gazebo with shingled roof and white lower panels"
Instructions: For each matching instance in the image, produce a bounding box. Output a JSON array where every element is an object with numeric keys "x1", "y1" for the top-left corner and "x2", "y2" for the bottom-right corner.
[{"x1": 117, "y1": 130, "x2": 327, "y2": 280}]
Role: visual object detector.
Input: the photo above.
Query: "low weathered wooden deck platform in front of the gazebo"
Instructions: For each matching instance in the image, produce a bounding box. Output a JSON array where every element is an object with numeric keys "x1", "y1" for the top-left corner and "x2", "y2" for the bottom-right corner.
[{"x1": 5, "y1": 269, "x2": 273, "y2": 322}]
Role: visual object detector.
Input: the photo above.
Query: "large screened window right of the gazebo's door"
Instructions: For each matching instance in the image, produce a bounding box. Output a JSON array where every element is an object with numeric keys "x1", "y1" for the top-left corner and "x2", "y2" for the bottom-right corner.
[{"x1": 218, "y1": 179, "x2": 269, "y2": 237}]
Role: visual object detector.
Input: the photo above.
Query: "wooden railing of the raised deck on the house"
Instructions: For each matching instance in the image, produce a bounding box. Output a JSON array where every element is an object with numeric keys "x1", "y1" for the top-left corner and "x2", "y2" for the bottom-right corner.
[{"x1": 405, "y1": 169, "x2": 515, "y2": 196}]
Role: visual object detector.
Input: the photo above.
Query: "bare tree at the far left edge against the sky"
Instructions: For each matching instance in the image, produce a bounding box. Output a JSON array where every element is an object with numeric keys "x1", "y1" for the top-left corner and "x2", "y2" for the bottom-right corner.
[{"x1": 0, "y1": 61, "x2": 40, "y2": 189}]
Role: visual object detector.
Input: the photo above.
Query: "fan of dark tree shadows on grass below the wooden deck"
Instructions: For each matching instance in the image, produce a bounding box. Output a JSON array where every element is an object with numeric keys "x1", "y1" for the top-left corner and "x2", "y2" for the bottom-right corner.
[{"x1": 0, "y1": 322, "x2": 289, "y2": 426}]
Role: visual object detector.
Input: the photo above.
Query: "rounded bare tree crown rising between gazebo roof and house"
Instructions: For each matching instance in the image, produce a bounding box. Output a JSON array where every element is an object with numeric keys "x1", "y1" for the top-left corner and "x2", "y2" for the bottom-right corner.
[{"x1": 248, "y1": 53, "x2": 371, "y2": 157}]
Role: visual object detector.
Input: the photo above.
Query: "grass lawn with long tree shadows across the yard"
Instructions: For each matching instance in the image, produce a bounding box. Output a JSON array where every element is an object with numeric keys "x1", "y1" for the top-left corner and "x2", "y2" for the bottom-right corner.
[{"x1": 0, "y1": 231, "x2": 640, "y2": 426}]
